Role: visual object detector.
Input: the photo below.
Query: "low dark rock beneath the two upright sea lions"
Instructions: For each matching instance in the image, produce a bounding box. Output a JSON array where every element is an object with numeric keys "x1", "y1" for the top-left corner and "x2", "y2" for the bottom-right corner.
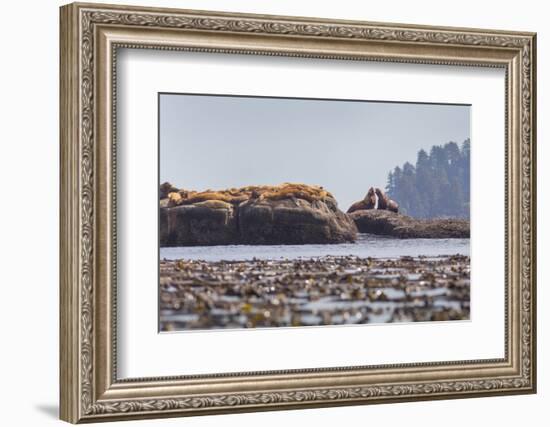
[{"x1": 349, "y1": 209, "x2": 470, "y2": 239}]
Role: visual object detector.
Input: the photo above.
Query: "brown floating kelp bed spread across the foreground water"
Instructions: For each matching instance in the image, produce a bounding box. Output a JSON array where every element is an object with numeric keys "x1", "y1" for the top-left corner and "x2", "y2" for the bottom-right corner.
[{"x1": 160, "y1": 255, "x2": 470, "y2": 331}]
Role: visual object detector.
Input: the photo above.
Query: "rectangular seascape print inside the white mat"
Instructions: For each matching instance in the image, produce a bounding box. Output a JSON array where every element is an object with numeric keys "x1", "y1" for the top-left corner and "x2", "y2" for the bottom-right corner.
[{"x1": 158, "y1": 93, "x2": 471, "y2": 332}]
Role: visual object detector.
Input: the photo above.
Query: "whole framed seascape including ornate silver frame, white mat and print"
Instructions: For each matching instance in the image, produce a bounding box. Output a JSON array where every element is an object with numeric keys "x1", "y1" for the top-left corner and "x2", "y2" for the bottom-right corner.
[{"x1": 60, "y1": 4, "x2": 536, "y2": 423}]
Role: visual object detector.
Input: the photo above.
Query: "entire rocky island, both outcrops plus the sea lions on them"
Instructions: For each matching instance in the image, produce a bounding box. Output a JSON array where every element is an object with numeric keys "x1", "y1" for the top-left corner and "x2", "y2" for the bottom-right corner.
[{"x1": 160, "y1": 183, "x2": 470, "y2": 247}]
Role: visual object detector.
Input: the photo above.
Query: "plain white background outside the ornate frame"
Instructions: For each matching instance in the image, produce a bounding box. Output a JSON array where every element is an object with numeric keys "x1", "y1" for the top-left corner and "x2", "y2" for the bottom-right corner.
[{"x1": 0, "y1": 0, "x2": 550, "y2": 427}]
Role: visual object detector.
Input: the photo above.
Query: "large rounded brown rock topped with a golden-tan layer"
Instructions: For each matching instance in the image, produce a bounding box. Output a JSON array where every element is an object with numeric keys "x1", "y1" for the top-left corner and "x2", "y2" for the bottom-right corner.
[{"x1": 160, "y1": 184, "x2": 357, "y2": 246}]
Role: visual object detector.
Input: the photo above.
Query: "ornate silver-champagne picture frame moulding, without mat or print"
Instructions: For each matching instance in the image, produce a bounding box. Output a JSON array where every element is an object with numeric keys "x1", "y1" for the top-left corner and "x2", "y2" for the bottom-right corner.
[{"x1": 60, "y1": 3, "x2": 536, "y2": 423}]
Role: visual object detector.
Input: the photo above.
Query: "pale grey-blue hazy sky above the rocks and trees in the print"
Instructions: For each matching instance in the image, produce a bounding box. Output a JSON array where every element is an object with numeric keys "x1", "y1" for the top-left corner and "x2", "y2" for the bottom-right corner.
[{"x1": 160, "y1": 94, "x2": 470, "y2": 211}]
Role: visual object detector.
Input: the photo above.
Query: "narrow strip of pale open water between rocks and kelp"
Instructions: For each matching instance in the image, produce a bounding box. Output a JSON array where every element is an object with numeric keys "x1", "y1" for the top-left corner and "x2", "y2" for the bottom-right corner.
[{"x1": 160, "y1": 234, "x2": 470, "y2": 261}]
